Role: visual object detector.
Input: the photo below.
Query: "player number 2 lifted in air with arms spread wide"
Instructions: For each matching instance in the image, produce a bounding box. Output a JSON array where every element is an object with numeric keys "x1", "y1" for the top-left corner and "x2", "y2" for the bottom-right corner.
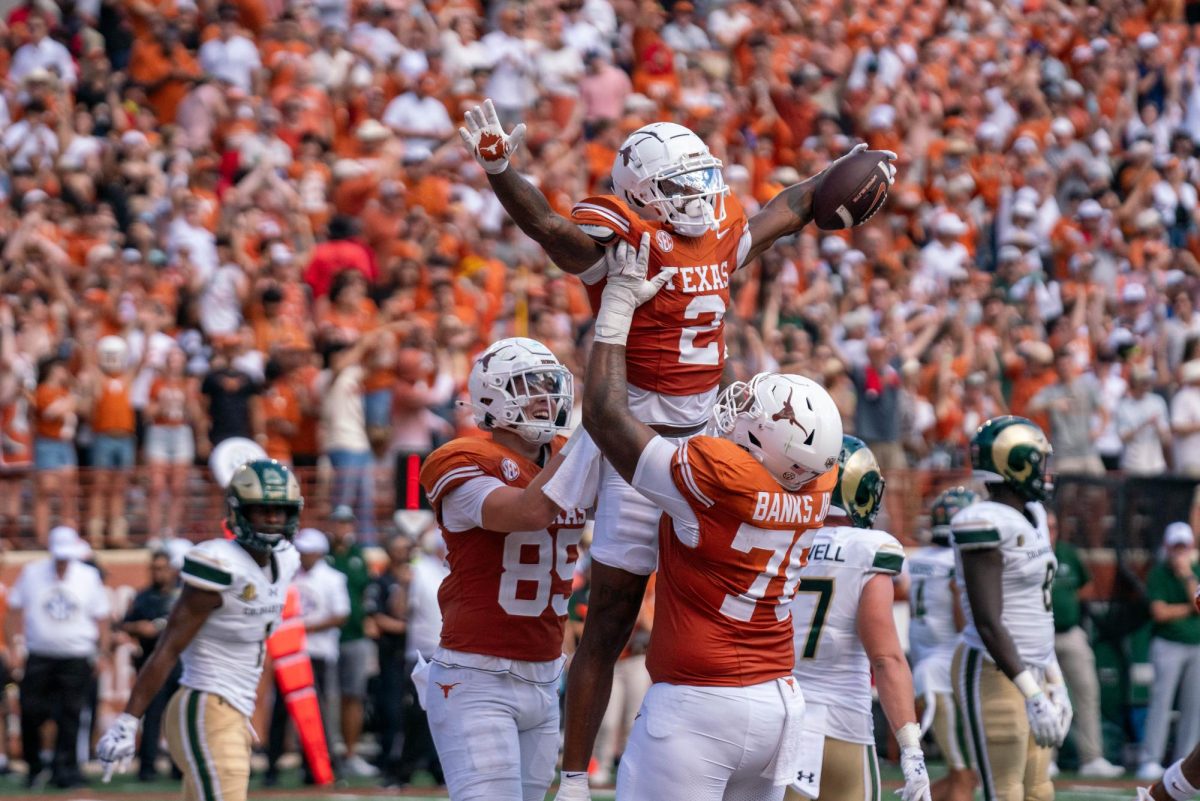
[{"x1": 460, "y1": 101, "x2": 895, "y2": 801}]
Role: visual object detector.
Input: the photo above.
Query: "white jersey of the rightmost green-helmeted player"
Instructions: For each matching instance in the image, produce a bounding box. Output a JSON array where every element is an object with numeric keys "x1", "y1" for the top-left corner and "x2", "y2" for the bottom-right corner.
[{"x1": 950, "y1": 501, "x2": 1058, "y2": 667}]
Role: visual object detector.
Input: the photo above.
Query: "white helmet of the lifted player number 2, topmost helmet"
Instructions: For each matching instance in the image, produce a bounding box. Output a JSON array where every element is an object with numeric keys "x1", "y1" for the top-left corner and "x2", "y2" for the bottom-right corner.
[{"x1": 612, "y1": 122, "x2": 730, "y2": 236}]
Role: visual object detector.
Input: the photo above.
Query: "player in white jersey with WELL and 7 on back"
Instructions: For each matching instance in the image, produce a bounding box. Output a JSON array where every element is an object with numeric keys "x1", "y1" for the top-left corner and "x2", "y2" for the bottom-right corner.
[{"x1": 787, "y1": 436, "x2": 929, "y2": 801}]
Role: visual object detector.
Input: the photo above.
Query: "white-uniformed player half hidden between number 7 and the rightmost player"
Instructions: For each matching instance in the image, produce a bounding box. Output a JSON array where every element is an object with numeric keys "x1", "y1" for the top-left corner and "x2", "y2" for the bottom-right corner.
[{"x1": 905, "y1": 487, "x2": 979, "y2": 801}]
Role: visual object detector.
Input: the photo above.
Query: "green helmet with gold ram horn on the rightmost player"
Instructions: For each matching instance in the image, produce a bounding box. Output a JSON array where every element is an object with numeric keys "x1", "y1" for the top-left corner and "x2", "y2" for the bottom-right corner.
[{"x1": 971, "y1": 415, "x2": 1054, "y2": 501}]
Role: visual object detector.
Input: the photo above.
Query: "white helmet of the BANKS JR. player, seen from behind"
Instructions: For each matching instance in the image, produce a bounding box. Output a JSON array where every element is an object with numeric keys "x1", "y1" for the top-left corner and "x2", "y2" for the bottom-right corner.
[{"x1": 712, "y1": 373, "x2": 841, "y2": 492}]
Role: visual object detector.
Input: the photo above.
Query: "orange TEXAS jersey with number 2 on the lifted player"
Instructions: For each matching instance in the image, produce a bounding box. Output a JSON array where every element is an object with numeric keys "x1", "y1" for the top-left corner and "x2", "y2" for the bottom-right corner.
[{"x1": 571, "y1": 194, "x2": 750, "y2": 396}]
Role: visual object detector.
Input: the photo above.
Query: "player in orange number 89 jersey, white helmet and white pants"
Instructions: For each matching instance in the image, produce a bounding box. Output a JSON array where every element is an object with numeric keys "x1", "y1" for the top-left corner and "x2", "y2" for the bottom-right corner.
[{"x1": 413, "y1": 337, "x2": 586, "y2": 801}]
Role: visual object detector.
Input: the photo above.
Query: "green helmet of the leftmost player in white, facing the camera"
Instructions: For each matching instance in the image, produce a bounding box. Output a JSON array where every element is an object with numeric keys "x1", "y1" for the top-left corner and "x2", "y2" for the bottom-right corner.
[{"x1": 226, "y1": 459, "x2": 304, "y2": 550}]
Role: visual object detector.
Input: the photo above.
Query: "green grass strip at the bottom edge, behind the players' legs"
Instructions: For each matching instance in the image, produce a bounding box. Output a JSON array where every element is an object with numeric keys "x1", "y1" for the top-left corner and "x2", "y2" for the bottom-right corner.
[{"x1": 0, "y1": 765, "x2": 1136, "y2": 801}]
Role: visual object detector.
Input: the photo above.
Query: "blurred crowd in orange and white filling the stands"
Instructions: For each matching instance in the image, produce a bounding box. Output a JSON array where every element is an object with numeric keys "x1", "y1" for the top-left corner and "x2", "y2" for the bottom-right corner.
[{"x1": 0, "y1": 0, "x2": 1200, "y2": 547}]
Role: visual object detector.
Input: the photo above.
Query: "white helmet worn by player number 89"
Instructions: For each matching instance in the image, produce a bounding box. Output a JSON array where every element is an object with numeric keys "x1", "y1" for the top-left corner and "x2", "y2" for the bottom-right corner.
[{"x1": 467, "y1": 337, "x2": 575, "y2": 445}]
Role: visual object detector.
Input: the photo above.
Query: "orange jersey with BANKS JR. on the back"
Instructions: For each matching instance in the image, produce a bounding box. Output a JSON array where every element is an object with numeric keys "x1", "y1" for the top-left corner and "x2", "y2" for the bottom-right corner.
[{"x1": 646, "y1": 436, "x2": 838, "y2": 687}]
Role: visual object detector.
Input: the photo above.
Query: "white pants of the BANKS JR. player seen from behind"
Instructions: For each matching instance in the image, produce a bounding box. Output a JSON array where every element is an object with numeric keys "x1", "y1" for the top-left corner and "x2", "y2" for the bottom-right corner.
[{"x1": 617, "y1": 679, "x2": 804, "y2": 801}]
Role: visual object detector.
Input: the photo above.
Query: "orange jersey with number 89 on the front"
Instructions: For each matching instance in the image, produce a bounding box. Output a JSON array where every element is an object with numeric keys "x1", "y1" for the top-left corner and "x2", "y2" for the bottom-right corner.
[{"x1": 421, "y1": 436, "x2": 587, "y2": 662}]
